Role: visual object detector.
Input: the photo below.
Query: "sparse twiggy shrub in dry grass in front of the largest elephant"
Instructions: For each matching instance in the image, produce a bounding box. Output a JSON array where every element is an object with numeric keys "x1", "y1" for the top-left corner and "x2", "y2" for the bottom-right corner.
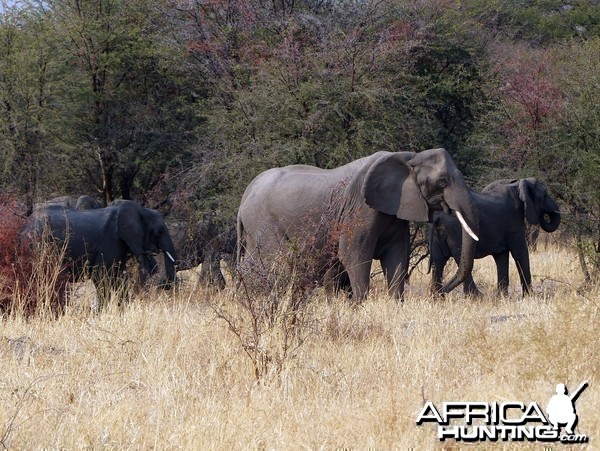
[{"x1": 219, "y1": 215, "x2": 343, "y2": 383}]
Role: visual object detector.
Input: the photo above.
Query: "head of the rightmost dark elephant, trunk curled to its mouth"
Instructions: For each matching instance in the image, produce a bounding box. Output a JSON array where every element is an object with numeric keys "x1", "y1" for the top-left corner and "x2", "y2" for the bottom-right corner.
[{"x1": 518, "y1": 178, "x2": 560, "y2": 233}]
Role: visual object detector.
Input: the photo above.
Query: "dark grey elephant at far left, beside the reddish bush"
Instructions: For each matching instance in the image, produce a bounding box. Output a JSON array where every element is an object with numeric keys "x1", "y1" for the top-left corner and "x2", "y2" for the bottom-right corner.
[{"x1": 26, "y1": 201, "x2": 176, "y2": 294}]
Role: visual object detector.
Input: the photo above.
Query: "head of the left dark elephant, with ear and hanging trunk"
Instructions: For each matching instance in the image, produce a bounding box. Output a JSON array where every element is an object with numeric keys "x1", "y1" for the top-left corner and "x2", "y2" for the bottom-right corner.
[{"x1": 112, "y1": 200, "x2": 176, "y2": 287}]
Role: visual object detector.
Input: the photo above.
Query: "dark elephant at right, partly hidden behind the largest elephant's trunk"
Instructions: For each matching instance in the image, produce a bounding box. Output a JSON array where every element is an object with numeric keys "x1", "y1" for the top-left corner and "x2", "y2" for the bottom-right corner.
[{"x1": 429, "y1": 178, "x2": 560, "y2": 295}]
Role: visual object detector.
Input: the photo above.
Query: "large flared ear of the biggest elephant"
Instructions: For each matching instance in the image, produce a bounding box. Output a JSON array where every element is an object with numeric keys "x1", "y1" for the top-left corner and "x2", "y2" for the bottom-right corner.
[{"x1": 363, "y1": 152, "x2": 429, "y2": 222}]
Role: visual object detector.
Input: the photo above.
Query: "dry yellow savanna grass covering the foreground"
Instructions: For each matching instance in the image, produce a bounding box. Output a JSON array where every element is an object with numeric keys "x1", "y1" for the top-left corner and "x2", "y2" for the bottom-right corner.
[{"x1": 0, "y1": 240, "x2": 600, "y2": 449}]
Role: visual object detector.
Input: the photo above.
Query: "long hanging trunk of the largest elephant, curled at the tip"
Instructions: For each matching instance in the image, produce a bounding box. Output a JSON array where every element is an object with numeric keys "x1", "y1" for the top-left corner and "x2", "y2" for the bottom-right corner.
[{"x1": 441, "y1": 182, "x2": 479, "y2": 293}]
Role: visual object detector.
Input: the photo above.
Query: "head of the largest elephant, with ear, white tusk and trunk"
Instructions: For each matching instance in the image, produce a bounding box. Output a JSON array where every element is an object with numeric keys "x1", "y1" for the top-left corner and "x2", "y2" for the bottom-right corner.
[{"x1": 363, "y1": 149, "x2": 479, "y2": 292}]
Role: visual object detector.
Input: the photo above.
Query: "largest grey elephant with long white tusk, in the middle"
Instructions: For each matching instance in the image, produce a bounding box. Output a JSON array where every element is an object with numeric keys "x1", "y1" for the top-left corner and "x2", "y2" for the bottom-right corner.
[{"x1": 237, "y1": 149, "x2": 479, "y2": 300}]
